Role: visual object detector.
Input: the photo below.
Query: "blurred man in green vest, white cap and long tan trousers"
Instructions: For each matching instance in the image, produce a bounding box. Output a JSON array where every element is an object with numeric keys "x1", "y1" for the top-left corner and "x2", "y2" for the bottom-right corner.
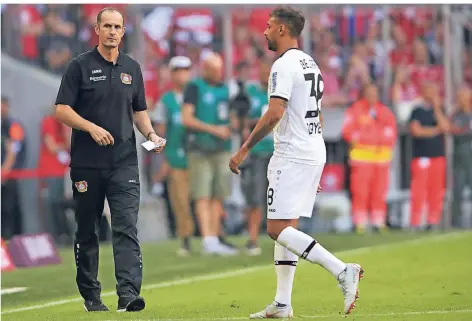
[{"x1": 153, "y1": 56, "x2": 195, "y2": 256}]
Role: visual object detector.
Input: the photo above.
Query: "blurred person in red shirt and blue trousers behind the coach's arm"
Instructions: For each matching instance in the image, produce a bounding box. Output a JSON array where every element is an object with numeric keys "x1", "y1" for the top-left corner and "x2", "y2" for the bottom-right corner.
[{"x1": 38, "y1": 106, "x2": 72, "y2": 243}]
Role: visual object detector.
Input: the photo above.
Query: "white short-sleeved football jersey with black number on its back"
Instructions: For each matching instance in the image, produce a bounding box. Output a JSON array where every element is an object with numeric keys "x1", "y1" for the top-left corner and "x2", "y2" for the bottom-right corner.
[{"x1": 268, "y1": 48, "x2": 326, "y2": 165}]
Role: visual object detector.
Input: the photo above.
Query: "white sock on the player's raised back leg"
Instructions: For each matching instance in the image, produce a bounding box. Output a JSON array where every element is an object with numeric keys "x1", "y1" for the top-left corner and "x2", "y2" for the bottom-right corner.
[{"x1": 277, "y1": 226, "x2": 346, "y2": 278}]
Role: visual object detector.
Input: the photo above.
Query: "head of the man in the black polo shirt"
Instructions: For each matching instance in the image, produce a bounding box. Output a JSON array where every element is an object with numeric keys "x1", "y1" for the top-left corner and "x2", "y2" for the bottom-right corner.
[{"x1": 95, "y1": 11, "x2": 125, "y2": 48}]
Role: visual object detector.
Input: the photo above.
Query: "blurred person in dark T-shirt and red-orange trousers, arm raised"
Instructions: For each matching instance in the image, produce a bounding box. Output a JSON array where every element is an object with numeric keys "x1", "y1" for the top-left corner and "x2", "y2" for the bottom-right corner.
[{"x1": 410, "y1": 82, "x2": 449, "y2": 230}]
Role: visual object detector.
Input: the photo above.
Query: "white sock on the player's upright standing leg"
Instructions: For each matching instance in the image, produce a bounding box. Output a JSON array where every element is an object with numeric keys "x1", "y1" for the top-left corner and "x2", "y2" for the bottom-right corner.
[{"x1": 274, "y1": 242, "x2": 298, "y2": 305}]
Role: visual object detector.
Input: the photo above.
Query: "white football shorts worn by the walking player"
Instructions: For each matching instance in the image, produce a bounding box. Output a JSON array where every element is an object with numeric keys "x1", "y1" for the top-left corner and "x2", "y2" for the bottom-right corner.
[{"x1": 267, "y1": 156, "x2": 324, "y2": 220}]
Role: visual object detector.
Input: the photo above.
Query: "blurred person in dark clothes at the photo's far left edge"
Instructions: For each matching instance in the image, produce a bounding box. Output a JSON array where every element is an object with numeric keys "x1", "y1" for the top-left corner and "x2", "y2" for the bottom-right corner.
[{"x1": 1, "y1": 96, "x2": 26, "y2": 240}]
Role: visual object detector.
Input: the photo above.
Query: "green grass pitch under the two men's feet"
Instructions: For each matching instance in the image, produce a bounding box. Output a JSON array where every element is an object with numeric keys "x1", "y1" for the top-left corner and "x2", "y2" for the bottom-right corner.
[{"x1": 1, "y1": 232, "x2": 472, "y2": 321}]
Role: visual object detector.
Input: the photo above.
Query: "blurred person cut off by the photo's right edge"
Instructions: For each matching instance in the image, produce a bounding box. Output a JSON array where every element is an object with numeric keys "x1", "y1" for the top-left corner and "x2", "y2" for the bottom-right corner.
[{"x1": 451, "y1": 86, "x2": 472, "y2": 228}]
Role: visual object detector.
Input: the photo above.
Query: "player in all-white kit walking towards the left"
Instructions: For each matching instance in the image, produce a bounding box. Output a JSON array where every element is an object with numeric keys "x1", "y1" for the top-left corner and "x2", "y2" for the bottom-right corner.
[{"x1": 229, "y1": 8, "x2": 364, "y2": 319}]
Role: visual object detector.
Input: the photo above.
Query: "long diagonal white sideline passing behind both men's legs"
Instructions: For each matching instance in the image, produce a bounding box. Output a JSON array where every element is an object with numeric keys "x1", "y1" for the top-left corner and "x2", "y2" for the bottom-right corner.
[{"x1": 1, "y1": 232, "x2": 470, "y2": 314}]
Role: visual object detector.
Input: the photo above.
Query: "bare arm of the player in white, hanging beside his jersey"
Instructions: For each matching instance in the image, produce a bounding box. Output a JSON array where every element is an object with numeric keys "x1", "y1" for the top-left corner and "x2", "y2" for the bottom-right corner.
[{"x1": 229, "y1": 97, "x2": 287, "y2": 174}]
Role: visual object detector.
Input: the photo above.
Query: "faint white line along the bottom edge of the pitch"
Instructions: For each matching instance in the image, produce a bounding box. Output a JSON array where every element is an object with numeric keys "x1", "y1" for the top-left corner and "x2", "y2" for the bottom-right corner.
[{"x1": 99, "y1": 309, "x2": 472, "y2": 321}]
